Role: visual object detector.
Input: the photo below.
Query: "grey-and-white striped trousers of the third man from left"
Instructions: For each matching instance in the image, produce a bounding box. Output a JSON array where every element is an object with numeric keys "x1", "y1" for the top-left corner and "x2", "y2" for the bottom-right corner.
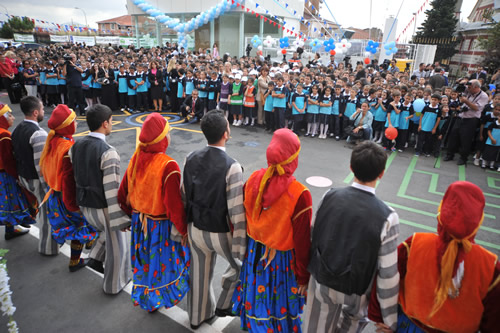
[{"x1": 188, "y1": 223, "x2": 241, "y2": 325}]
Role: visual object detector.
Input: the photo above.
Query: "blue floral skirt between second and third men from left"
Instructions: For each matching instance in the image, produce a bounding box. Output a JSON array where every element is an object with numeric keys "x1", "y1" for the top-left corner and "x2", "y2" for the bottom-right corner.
[{"x1": 130, "y1": 212, "x2": 190, "y2": 311}]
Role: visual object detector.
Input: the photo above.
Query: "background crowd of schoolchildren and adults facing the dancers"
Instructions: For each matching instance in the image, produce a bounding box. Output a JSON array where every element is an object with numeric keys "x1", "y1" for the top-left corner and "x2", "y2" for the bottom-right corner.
[{"x1": 0, "y1": 45, "x2": 500, "y2": 169}]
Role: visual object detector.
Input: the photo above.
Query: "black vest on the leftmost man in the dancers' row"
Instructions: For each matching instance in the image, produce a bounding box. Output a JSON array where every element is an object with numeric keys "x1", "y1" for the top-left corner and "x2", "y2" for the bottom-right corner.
[{"x1": 12, "y1": 121, "x2": 40, "y2": 179}]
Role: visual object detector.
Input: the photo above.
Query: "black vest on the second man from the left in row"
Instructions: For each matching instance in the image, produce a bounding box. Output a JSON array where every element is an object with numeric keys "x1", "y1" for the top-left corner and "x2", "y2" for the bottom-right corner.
[{"x1": 71, "y1": 136, "x2": 110, "y2": 208}]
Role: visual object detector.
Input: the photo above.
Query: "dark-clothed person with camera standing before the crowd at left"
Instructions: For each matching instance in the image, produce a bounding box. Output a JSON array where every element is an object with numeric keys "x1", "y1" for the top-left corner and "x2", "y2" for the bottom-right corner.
[{"x1": 62, "y1": 53, "x2": 86, "y2": 116}]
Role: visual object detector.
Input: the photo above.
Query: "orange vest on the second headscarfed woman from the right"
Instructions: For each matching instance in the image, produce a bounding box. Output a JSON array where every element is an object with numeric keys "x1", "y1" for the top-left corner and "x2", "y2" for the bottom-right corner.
[{"x1": 244, "y1": 173, "x2": 307, "y2": 251}]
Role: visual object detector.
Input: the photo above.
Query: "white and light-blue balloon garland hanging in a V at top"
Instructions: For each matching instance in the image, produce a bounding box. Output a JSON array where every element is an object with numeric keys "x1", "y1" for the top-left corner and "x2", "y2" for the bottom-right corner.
[{"x1": 133, "y1": 0, "x2": 237, "y2": 34}]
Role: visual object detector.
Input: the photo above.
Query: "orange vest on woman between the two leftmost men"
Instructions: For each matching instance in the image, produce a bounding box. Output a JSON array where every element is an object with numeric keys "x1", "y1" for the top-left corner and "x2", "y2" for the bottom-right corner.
[{"x1": 41, "y1": 137, "x2": 73, "y2": 192}]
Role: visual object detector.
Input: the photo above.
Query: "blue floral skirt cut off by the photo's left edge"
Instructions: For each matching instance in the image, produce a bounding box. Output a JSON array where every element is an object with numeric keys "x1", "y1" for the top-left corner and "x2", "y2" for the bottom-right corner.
[{"x1": 0, "y1": 171, "x2": 36, "y2": 226}]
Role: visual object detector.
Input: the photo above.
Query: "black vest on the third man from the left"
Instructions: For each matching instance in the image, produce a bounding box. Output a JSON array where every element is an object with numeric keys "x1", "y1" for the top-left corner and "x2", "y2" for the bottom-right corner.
[{"x1": 184, "y1": 147, "x2": 235, "y2": 232}]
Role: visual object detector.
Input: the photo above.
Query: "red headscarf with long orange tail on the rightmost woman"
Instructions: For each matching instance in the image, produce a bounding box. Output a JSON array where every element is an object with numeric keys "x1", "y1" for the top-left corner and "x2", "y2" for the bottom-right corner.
[{"x1": 431, "y1": 181, "x2": 485, "y2": 317}]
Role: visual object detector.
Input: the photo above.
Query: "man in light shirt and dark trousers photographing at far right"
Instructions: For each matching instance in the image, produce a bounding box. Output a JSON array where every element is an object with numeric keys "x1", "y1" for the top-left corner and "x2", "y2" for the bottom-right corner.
[{"x1": 444, "y1": 80, "x2": 488, "y2": 165}]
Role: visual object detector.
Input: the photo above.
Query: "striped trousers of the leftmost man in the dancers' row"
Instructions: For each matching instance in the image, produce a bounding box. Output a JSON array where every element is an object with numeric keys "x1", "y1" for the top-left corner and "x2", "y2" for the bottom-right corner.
[{"x1": 19, "y1": 176, "x2": 59, "y2": 256}]
